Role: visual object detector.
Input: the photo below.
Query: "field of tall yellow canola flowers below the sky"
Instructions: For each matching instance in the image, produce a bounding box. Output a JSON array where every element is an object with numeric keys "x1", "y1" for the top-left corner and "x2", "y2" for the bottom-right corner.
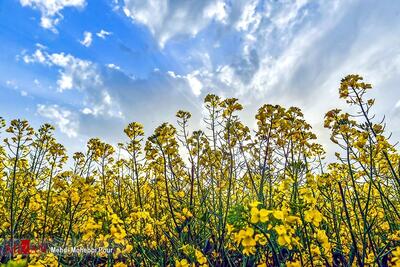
[{"x1": 0, "y1": 75, "x2": 400, "y2": 267}]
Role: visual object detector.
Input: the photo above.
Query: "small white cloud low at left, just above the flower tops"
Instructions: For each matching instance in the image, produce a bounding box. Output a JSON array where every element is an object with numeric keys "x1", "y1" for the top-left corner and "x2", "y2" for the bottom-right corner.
[{"x1": 36, "y1": 104, "x2": 79, "y2": 138}]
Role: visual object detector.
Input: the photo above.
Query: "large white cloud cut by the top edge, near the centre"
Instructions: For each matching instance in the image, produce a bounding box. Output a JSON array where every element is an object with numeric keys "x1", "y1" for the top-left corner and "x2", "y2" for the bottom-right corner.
[{"x1": 124, "y1": 0, "x2": 227, "y2": 47}]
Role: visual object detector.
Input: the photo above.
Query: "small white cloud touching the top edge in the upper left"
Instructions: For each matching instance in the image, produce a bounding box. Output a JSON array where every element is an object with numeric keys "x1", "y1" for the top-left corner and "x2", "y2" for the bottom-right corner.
[{"x1": 20, "y1": 0, "x2": 86, "y2": 32}]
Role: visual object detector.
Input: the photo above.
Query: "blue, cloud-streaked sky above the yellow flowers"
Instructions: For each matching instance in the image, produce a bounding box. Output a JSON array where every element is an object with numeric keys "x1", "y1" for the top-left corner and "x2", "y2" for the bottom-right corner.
[{"x1": 0, "y1": 0, "x2": 400, "y2": 156}]
